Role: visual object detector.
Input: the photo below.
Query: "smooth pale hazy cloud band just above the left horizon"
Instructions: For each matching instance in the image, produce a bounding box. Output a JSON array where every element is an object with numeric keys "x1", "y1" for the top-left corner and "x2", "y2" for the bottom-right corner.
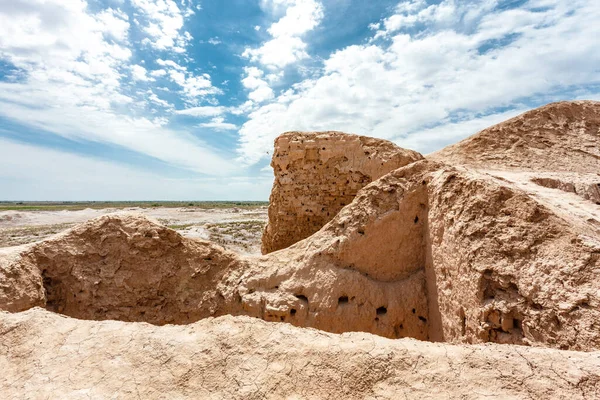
[{"x1": 0, "y1": 138, "x2": 273, "y2": 201}]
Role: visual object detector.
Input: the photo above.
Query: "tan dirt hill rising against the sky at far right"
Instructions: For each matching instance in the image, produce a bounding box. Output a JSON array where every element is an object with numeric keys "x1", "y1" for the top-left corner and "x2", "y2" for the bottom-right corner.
[{"x1": 428, "y1": 101, "x2": 600, "y2": 174}]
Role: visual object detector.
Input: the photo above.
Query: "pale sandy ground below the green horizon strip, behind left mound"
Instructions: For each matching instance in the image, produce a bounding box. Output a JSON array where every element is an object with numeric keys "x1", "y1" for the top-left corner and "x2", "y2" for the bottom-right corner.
[{"x1": 0, "y1": 206, "x2": 267, "y2": 254}]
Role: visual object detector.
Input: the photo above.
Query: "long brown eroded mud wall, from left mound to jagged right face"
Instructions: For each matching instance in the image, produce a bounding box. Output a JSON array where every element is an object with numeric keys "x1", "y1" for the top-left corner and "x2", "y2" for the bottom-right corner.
[{"x1": 0, "y1": 161, "x2": 600, "y2": 350}]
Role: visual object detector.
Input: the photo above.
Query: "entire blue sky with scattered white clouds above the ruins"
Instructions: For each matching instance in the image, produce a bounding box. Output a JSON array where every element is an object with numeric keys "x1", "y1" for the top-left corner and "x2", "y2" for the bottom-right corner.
[{"x1": 0, "y1": 0, "x2": 600, "y2": 201}]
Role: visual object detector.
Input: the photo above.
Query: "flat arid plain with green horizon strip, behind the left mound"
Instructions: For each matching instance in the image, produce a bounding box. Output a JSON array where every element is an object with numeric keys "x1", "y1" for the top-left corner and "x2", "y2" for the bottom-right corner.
[{"x1": 0, "y1": 201, "x2": 268, "y2": 254}]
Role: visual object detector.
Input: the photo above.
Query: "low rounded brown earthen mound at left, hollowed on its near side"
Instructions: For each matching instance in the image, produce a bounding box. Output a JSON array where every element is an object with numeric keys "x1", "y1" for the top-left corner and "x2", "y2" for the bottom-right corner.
[{"x1": 0, "y1": 214, "x2": 244, "y2": 324}]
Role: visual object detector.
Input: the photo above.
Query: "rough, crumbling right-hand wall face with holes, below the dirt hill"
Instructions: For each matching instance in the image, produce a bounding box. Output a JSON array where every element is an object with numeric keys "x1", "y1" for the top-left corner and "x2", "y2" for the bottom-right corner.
[{"x1": 429, "y1": 167, "x2": 600, "y2": 350}]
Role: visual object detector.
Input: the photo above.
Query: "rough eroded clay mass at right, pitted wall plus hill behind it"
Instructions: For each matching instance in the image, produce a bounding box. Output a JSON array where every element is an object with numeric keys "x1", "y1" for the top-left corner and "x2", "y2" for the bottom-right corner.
[{"x1": 429, "y1": 101, "x2": 600, "y2": 350}]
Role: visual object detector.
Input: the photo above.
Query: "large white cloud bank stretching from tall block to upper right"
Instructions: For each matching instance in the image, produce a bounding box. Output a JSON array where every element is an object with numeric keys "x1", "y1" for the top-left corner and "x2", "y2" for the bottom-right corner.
[{"x1": 239, "y1": 0, "x2": 600, "y2": 164}]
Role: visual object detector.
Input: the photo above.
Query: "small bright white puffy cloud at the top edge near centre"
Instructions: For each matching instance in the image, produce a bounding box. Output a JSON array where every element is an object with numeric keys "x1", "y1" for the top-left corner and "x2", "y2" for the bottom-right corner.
[{"x1": 242, "y1": 0, "x2": 324, "y2": 69}]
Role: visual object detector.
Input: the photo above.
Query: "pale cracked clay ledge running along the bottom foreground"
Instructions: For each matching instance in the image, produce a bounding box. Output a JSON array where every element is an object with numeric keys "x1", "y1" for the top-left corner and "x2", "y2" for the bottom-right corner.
[{"x1": 0, "y1": 309, "x2": 600, "y2": 400}]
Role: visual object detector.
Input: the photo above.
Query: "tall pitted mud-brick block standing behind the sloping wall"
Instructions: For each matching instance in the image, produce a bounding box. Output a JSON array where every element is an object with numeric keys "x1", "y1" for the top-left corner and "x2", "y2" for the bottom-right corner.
[{"x1": 262, "y1": 132, "x2": 423, "y2": 254}]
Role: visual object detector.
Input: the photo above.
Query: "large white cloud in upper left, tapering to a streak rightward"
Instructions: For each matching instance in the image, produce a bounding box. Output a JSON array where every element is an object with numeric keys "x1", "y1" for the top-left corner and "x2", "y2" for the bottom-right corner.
[{"x1": 0, "y1": 0, "x2": 235, "y2": 175}]
